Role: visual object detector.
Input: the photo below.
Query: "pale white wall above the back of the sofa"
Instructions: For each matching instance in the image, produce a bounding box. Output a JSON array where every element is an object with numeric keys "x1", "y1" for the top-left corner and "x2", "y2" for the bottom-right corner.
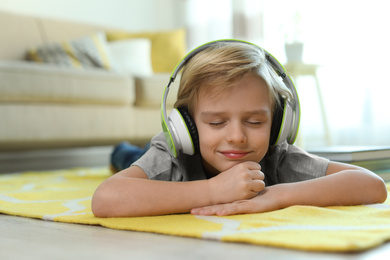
[{"x1": 0, "y1": 0, "x2": 183, "y2": 31}]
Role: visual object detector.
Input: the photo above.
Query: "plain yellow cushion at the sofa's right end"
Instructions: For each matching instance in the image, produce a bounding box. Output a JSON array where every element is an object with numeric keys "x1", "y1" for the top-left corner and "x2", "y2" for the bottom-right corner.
[{"x1": 106, "y1": 29, "x2": 186, "y2": 73}]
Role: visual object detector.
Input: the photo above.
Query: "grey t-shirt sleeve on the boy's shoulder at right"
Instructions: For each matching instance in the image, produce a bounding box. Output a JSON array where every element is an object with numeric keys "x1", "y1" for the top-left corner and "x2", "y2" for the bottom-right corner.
[{"x1": 262, "y1": 142, "x2": 329, "y2": 185}]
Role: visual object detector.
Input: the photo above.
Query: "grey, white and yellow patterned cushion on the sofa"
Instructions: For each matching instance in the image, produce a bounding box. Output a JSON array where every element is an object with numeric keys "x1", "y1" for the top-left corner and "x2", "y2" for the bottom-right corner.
[{"x1": 27, "y1": 32, "x2": 116, "y2": 70}]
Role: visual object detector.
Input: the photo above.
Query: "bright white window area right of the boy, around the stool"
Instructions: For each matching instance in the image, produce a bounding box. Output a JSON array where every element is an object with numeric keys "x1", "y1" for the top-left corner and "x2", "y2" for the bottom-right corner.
[{"x1": 264, "y1": 0, "x2": 390, "y2": 147}]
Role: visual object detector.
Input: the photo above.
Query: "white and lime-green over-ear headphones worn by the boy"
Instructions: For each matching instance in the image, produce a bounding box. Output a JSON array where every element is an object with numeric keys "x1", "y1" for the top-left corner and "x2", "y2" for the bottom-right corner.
[{"x1": 161, "y1": 39, "x2": 300, "y2": 157}]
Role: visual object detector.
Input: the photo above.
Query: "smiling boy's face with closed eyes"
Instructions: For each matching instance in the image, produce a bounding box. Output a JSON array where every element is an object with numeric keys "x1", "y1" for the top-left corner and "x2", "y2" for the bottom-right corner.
[{"x1": 194, "y1": 75, "x2": 272, "y2": 176}]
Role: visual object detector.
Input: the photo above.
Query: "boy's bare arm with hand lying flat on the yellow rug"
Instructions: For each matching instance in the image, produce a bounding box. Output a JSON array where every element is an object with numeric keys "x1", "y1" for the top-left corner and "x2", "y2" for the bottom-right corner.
[{"x1": 191, "y1": 162, "x2": 387, "y2": 215}]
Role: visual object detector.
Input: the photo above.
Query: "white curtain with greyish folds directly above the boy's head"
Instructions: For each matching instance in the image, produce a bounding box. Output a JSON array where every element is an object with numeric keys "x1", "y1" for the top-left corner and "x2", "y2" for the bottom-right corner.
[{"x1": 183, "y1": 0, "x2": 263, "y2": 50}]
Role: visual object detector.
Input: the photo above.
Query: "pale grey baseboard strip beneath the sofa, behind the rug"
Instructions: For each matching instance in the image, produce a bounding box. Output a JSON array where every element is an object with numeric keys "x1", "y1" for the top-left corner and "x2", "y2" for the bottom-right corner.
[{"x1": 0, "y1": 146, "x2": 113, "y2": 173}]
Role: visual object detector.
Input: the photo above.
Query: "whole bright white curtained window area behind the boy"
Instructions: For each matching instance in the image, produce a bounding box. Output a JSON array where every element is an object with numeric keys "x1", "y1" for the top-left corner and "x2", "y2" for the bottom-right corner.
[{"x1": 183, "y1": 0, "x2": 390, "y2": 148}]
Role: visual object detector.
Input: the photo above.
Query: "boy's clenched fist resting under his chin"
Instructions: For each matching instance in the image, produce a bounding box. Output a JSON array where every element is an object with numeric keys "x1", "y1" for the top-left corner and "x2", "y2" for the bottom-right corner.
[{"x1": 209, "y1": 162, "x2": 265, "y2": 204}]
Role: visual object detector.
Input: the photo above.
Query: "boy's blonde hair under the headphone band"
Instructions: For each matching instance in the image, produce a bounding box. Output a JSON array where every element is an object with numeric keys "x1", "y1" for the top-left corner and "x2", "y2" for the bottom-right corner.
[{"x1": 174, "y1": 42, "x2": 292, "y2": 115}]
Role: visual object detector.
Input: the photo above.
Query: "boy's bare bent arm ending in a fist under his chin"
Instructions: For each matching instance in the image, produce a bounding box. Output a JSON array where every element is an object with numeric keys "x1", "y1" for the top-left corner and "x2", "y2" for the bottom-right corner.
[{"x1": 92, "y1": 162, "x2": 264, "y2": 217}]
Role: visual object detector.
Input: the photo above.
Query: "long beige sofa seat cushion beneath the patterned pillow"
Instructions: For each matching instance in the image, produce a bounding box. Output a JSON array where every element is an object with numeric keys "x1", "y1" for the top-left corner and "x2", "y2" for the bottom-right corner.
[{"x1": 0, "y1": 61, "x2": 135, "y2": 105}]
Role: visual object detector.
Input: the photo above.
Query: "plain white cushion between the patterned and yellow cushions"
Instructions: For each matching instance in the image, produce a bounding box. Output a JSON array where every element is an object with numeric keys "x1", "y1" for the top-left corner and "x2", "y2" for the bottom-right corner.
[{"x1": 108, "y1": 38, "x2": 153, "y2": 76}]
